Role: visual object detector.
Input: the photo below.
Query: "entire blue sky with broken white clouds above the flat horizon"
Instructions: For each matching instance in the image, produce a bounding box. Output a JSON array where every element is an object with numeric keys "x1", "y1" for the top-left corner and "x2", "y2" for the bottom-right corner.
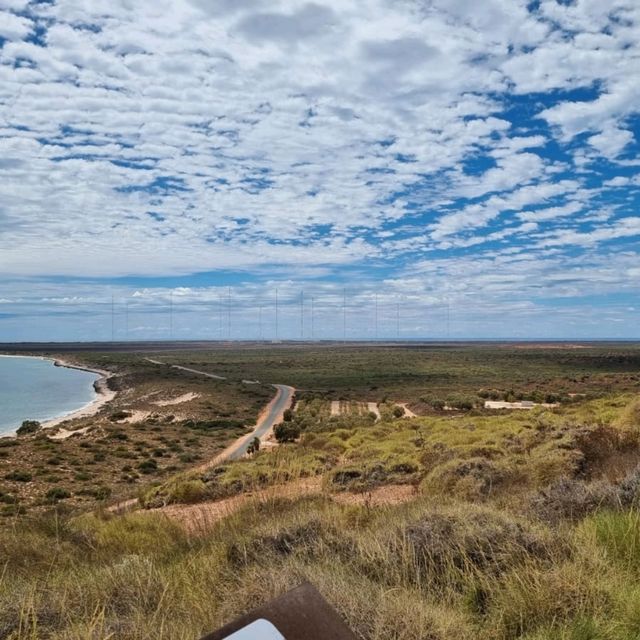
[{"x1": 0, "y1": 0, "x2": 640, "y2": 341}]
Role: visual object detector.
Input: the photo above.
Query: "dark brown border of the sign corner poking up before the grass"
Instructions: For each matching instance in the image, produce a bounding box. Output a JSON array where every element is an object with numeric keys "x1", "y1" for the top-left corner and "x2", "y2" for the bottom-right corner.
[{"x1": 202, "y1": 583, "x2": 356, "y2": 640}]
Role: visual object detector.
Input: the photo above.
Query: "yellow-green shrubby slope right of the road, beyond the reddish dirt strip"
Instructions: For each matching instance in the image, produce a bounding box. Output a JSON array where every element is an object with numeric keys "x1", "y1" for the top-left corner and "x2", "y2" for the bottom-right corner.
[{"x1": 142, "y1": 395, "x2": 640, "y2": 507}]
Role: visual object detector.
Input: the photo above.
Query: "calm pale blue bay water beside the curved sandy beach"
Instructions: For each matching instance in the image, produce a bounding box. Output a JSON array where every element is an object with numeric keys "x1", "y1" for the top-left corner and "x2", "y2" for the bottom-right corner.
[{"x1": 0, "y1": 356, "x2": 99, "y2": 436}]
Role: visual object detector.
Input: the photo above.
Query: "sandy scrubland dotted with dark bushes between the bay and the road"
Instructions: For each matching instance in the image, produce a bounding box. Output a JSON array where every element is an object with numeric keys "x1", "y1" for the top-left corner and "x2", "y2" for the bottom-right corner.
[{"x1": 0, "y1": 354, "x2": 275, "y2": 510}]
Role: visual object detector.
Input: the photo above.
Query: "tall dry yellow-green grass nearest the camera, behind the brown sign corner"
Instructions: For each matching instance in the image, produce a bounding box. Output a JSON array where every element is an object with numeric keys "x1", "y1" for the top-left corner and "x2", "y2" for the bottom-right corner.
[{"x1": 0, "y1": 497, "x2": 640, "y2": 640}]
